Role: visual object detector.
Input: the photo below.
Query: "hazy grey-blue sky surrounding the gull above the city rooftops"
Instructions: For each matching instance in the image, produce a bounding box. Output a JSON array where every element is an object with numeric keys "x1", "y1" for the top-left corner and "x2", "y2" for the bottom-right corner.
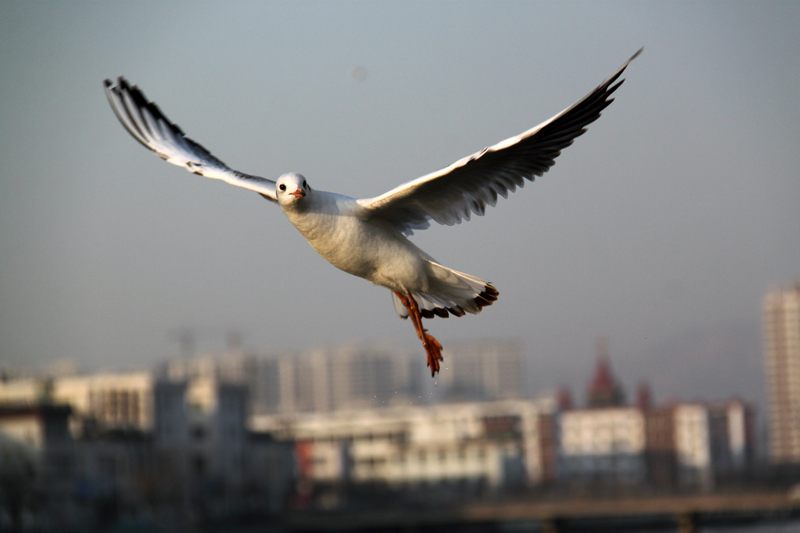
[{"x1": 0, "y1": 1, "x2": 800, "y2": 408}]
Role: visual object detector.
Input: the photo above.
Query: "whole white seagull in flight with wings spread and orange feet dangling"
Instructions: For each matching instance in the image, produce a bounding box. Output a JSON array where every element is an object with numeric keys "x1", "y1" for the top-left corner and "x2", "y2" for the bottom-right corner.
[{"x1": 104, "y1": 49, "x2": 642, "y2": 376}]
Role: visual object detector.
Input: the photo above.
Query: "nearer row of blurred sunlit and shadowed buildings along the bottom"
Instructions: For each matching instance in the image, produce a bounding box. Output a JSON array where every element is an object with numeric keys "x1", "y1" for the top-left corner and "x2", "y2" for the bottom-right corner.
[{"x1": 0, "y1": 368, "x2": 756, "y2": 530}]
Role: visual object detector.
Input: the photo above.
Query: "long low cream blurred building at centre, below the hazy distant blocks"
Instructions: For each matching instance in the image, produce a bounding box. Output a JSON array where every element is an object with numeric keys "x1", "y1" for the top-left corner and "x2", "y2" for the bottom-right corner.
[{"x1": 253, "y1": 399, "x2": 555, "y2": 492}]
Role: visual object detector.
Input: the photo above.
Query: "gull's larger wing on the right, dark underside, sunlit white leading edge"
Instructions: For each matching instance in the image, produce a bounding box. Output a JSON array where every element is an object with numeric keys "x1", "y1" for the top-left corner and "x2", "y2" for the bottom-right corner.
[{"x1": 358, "y1": 50, "x2": 642, "y2": 235}]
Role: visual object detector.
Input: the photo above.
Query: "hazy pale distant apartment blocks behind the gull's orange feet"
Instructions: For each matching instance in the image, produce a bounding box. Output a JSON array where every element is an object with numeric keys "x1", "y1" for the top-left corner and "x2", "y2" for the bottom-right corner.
[{"x1": 157, "y1": 340, "x2": 525, "y2": 415}]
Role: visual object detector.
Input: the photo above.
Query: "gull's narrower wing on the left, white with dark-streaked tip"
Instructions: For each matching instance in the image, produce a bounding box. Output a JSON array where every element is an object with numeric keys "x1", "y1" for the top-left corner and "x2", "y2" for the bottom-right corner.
[{"x1": 104, "y1": 76, "x2": 277, "y2": 202}]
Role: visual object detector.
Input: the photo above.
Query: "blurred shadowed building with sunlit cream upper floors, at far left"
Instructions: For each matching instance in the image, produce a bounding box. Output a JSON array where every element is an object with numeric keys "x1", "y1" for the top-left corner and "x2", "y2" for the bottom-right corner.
[{"x1": 0, "y1": 375, "x2": 294, "y2": 531}]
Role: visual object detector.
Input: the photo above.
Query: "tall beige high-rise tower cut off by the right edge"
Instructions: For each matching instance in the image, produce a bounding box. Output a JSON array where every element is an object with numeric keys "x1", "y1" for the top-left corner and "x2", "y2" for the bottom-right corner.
[{"x1": 763, "y1": 280, "x2": 800, "y2": 464}]
